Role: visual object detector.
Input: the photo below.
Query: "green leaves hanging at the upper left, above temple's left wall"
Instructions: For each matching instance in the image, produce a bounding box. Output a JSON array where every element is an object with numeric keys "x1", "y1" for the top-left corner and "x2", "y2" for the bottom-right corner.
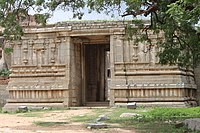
[{"x1": 0, "y1": 0, "x2": 85, "y2": 40}]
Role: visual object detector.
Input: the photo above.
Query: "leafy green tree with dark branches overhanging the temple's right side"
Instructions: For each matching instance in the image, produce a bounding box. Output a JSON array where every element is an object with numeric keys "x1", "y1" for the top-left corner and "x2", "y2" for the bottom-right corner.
[{"x1": 88, "y1": 0, "x2": 200, "y2": 67}]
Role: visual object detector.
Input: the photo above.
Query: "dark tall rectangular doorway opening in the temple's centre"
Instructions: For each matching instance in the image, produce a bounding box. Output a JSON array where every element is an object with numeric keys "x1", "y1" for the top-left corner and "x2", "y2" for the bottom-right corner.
[{"x1": 83, "y1": 44, "x2": 109, "y2": 103}]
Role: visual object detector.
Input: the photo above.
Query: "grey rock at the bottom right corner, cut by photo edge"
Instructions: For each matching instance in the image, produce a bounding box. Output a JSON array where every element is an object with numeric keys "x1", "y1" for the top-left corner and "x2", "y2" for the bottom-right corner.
[{"x1": 184, "y1": 118, "x2": 200, "y2": 131}]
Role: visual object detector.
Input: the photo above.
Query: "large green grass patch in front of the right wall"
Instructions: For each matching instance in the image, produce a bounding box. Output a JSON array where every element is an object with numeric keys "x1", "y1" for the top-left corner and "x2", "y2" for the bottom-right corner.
[{"x1": 72, "y1": 107, "x2": 200, "y2": 133}]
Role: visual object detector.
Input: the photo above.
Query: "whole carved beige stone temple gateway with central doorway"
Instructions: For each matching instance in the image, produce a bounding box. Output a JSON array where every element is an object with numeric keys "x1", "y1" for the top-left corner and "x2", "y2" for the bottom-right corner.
[{"x1": 4, "y1": 21, "x2": 199, "y2": 109}]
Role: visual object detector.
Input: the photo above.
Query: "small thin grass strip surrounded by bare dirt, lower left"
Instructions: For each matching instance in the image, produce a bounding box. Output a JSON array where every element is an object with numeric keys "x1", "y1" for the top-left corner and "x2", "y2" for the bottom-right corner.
[{"x1": 33, "y1": 121, "x2": 68, "y2": 127}]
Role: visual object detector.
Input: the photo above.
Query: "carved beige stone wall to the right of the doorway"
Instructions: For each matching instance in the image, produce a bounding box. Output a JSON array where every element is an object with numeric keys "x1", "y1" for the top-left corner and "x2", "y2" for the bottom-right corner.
[{"x1": 110, "y1": 34, "x2": 196, "y2": 107}]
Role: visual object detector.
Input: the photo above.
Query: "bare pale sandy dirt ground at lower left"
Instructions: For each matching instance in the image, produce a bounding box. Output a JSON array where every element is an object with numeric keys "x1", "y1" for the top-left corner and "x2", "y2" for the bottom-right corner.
[{"x1": 0, "y1": 109, "x2": 134, "y2": 133}]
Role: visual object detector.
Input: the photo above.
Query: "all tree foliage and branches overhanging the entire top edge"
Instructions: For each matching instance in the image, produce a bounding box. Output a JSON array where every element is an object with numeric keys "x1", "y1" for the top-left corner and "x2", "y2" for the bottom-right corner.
[{"x1": 0, "y1": 0, "x2": 200, "y2": 67}]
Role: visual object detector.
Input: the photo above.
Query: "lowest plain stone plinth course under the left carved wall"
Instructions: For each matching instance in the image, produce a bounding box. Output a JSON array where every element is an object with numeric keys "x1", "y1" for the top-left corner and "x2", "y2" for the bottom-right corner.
[{"x1": 2, "y1": 103, "x2": 64, "y2": 112}]
